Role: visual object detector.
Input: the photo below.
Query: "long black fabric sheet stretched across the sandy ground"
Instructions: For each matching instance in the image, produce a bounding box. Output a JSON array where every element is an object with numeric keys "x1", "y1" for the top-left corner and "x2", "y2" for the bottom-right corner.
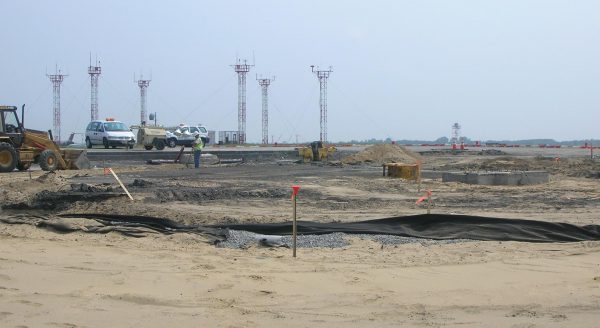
[{"x1": 0, "y1": 213, "x2": 600, "y2": 242}]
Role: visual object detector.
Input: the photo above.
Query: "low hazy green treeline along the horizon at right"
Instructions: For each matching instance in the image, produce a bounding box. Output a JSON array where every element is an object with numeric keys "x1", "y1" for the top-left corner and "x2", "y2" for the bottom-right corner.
[{"x1": 340, "y1": 137, "x2": 600, "y2": 146}]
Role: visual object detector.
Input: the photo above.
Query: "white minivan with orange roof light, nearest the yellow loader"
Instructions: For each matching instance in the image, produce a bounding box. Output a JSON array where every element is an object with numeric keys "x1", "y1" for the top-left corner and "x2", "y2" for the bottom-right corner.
[{"x1": 85, "y1": 118, "x2": 135, "y2": 148}]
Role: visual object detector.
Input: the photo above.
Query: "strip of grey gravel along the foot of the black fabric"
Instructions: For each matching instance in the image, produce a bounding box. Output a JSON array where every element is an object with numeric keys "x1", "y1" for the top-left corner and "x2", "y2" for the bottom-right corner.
[{"x1": 217, "y1": 230, "x2": 471, "y2": 248}]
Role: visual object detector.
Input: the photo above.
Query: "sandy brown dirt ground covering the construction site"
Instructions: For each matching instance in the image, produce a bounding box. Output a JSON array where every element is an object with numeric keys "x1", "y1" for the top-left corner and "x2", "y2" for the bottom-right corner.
[{"x1": 0, "y1": 145, "x2": 600, "y2": 327}]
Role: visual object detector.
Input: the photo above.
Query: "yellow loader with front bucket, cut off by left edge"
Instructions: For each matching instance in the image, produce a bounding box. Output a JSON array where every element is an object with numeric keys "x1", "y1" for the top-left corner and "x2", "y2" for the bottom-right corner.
[{"x1": 0, "y1": 105, "x2": 90, "y2": 172}]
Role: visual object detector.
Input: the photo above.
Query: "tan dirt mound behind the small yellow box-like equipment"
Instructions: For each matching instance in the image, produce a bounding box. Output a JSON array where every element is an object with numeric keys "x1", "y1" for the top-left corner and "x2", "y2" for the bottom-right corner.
[{"x1": 342, "y1": 144, "x2": 421, "y2": 165}]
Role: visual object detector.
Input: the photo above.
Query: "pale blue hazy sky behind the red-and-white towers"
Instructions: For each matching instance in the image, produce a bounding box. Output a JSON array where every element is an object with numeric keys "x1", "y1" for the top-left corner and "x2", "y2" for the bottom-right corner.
[{"x1": 0, "y1": 0, "x2": 600, "y2": 142}]
